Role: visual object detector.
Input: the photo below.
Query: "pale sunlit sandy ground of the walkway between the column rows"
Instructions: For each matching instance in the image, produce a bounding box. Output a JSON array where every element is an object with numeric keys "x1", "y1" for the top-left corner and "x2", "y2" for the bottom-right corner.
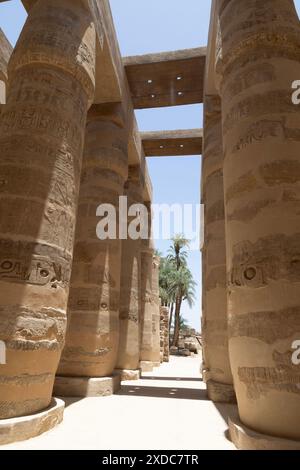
[{"x1": 0, "y1": 356, "x2": 234, "y2": 450}]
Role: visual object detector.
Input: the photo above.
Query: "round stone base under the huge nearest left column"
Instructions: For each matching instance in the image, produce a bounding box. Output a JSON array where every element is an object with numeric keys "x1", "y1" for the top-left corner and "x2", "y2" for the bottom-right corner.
[{"x1": 0, "y1": 398, "x2": 65, "y2": 445}]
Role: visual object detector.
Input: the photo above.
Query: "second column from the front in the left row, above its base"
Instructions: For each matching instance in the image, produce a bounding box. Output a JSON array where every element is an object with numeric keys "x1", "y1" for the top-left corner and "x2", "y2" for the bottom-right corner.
[{"x1": 58, "y1": 103, "x2": 128, "y2": 377}]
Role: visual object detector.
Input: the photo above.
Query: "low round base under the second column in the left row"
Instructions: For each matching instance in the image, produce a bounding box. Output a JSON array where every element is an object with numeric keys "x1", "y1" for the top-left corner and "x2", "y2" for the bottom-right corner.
[{"x1": 54, "y1": 373, "x2": 121, "y2": 397}]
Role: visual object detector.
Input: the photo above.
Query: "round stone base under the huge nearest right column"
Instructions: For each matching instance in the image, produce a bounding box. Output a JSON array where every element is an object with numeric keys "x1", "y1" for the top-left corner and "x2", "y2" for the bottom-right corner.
[{"x1": 228, "y1": 415, "x2": 300, "y2": 450}]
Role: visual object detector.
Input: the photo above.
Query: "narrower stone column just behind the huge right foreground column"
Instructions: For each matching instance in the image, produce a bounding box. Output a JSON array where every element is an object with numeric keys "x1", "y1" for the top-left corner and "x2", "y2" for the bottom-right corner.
[{"x1": 202, "y1": 96, "x2": 235, "y2": 402}]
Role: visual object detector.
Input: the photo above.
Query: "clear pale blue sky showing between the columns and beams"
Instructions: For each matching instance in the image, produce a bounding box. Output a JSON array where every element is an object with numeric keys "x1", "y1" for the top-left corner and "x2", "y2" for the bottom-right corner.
[{"x1": 0, "y1": 0, "x2": 300, "y2": 329}]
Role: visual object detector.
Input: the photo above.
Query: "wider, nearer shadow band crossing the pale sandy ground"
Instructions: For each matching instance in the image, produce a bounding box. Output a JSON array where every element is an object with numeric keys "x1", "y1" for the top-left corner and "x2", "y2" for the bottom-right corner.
[{"x1": 117, "y1": 385, "x2": 208, "y2": 400}]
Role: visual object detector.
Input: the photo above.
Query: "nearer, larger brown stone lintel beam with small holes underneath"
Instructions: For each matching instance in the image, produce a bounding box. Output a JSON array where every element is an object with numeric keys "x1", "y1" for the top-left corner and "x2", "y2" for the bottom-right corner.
[{"x1": 123, "y1": 47, "x2": 206, "y2": 109}]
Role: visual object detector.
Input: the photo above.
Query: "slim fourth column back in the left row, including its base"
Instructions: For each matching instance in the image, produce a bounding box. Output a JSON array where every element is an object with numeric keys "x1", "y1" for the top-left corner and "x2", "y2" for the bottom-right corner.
[{"x1": 140, "y1": 203, "x2": 154, "y2": 372}]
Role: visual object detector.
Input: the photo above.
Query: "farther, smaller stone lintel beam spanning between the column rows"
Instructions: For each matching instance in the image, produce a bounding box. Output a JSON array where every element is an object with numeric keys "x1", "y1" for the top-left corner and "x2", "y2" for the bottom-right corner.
[{"x1": 141, "y1": 129, "x2": 203, "y2": 157}]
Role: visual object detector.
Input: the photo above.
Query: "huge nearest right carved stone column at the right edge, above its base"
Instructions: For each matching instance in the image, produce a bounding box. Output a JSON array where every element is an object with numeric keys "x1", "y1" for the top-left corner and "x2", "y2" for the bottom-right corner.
[{"x1": 217, "y1": 0, "x2": 300, "y2": 443}]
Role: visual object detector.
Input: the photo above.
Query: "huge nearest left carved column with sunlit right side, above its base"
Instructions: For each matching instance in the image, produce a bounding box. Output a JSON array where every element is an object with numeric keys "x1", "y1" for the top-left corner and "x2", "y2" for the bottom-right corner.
[{"x1": 0, "y1": 0, "x2": 96, "y2": 418}]
